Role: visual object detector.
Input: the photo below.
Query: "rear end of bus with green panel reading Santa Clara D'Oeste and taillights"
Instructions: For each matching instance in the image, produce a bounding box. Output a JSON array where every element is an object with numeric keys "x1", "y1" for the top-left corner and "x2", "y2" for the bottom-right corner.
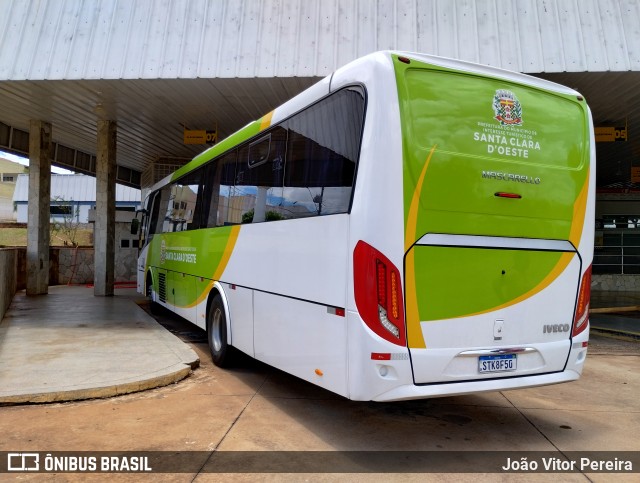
[{"x1": 354, "y1": 54, "x2": 595, "y2": 400}]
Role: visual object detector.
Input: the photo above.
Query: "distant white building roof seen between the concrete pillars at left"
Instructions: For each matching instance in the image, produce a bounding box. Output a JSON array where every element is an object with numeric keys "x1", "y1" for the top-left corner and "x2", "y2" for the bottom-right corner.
[{"x1": 13, "y1": 174, "x2": 140, "y2": 203}]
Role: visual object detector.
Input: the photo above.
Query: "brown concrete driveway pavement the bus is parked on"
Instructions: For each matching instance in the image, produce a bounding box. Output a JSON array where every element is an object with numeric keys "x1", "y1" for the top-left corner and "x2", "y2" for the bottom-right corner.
[{"x1": 0, "y1": 300, "x2": 640, "y2": 482}]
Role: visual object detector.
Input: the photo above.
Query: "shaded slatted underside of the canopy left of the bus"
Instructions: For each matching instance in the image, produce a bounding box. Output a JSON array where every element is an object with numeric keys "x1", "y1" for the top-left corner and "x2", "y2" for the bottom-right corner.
[{"x1": 0, "y1": 78, "x2": 317, "y2": 177}]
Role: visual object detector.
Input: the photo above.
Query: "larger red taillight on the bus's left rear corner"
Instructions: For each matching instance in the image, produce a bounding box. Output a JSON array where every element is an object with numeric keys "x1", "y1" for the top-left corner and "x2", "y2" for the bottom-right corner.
[{"x1": 353, "y1": 240, "x2": 406, "y2": 346}]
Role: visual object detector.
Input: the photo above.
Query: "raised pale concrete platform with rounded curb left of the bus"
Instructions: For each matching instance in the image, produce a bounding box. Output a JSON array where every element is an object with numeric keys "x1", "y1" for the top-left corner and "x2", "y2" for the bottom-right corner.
[{"x1": 0, "y1": 286, "x2": 198, "y2": 403}]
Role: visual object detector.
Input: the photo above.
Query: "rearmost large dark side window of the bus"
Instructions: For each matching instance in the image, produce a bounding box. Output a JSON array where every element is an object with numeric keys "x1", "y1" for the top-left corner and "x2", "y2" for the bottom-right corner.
[{"x1": 282, "y1": 87, "x2": 364, "y2": 218}]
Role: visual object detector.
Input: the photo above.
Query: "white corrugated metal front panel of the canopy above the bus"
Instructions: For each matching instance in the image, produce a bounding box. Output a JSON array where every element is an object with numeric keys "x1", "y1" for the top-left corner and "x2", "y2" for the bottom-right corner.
[{"x1": 0, "y1": 0, "x2": 640, "y2": 80}]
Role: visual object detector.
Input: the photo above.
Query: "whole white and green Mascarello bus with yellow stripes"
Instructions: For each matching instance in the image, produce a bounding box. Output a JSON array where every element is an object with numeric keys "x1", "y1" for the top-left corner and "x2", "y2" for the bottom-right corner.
[{"x1": 137, "y1": 51, "x2": 595, "y2": 401}]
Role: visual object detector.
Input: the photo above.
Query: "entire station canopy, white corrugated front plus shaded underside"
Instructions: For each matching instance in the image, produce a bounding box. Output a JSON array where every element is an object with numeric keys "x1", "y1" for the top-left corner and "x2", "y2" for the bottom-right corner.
[{"x1": 0, "y1": 0, "x2": 640, "y2": 189}]
